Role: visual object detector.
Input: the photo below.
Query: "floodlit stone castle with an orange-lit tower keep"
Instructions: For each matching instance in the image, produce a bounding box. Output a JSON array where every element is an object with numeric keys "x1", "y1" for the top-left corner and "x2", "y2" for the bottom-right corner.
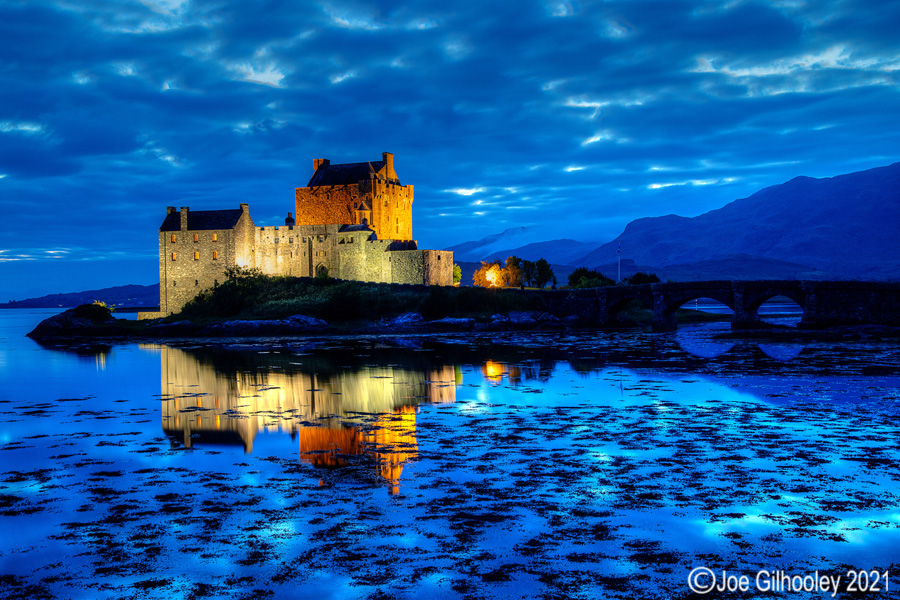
[{"x1": 138, "y1": 152, "x2": 453, "y2": 319}]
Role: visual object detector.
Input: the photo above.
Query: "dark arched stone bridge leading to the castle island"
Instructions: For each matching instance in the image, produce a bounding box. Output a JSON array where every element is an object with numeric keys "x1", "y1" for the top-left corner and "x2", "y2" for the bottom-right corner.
[{"x1": 536, "y1": 280, "x2": 900, "y2": 331}]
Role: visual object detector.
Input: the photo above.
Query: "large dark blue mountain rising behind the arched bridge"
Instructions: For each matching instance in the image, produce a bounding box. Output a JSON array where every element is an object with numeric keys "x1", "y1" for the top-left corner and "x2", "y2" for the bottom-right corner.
[{"x1": 569, "y1": 163, "x2": 900, "y2": 279}]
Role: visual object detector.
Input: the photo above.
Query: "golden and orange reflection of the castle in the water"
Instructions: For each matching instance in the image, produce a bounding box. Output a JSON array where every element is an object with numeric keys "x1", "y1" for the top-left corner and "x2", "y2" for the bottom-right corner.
[{"x1": 151, "y1": 345, "x2": 462, "y2": 493}]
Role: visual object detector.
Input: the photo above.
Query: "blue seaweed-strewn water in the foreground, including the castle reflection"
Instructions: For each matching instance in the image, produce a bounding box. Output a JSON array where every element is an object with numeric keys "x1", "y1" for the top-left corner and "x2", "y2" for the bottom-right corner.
[{"x1": 0, "y1": 311, "x2": 900, "y2": 598}]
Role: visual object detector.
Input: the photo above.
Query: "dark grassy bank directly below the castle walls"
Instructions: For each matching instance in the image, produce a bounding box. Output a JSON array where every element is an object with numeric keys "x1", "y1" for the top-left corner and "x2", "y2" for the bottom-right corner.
[{"x1": 174, "y1": 275, "x2": 542, "y2": 322}]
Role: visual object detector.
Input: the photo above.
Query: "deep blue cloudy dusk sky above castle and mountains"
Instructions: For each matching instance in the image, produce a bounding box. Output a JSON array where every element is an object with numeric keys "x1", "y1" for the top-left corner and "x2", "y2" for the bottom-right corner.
[{"x1": 0, "y1": 0, "x2": 900, "y2": 301}]
